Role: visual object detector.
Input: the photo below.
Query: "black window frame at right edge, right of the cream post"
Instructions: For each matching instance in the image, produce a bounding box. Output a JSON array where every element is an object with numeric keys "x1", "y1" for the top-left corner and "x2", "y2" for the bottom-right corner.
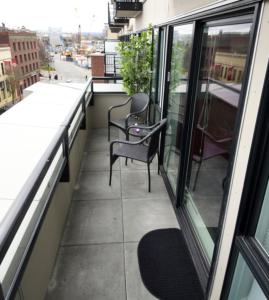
[{"x1": 222, "y1": 62, "x2": 269, "y2": 299}]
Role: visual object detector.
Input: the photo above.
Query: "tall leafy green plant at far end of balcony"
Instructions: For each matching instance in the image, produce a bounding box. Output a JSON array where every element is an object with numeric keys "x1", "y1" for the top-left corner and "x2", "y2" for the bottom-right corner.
[{"x1": 118, "y1": 27, "x2": 152, "y2": 95}]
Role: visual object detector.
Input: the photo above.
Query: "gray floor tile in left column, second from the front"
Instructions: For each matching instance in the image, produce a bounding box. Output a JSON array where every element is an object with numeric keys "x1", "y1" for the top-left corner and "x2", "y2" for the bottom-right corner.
[{"x1": 62, "y1": 200, "x2": 123, "y2": 245}]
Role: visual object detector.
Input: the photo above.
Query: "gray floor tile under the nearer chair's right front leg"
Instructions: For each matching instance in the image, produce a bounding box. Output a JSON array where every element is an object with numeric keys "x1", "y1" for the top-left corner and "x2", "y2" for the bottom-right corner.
[{"x1": 121, "y1": 170, "x2": 168, "y2": 199}]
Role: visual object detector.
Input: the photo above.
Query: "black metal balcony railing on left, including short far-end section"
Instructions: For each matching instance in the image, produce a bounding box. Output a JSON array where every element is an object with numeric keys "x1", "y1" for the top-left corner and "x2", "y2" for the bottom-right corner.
[{"x1": 0, "y1": 77, "x2": 122, "y2": 300}]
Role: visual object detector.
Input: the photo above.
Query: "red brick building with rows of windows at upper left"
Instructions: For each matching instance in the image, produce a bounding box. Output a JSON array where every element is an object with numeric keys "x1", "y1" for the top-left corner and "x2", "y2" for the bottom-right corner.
[{"x1": 0, "y1": 29, "x2": 40, "y2": 96}]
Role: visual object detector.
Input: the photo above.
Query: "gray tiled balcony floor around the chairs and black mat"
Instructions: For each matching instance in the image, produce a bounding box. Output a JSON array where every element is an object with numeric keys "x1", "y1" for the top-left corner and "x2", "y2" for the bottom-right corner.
[{"x1": 46, "y1": 129, "x2": 178, "y2": 300}]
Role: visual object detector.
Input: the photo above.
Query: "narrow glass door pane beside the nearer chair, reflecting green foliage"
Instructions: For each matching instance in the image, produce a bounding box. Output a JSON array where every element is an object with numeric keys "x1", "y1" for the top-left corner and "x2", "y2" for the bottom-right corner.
[{"x1": 163, "y1": 24, "x2": 193, "y2": 194}]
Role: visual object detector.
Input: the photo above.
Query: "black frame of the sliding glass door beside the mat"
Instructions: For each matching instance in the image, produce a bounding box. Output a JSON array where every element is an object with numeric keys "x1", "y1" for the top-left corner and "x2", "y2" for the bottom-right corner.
[{"x1": 157, "y1": 1, "x2": 261, "y2": 295}]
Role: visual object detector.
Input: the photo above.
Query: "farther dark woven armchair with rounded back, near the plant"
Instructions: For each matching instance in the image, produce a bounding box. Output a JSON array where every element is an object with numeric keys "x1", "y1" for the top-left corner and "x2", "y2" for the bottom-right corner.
[{"x1": 107, "y1": 93, "x2": 149, "y2": 141}]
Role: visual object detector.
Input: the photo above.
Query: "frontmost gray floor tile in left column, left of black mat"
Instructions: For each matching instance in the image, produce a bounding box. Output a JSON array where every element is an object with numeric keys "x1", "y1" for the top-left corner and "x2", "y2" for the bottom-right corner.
[{"x1": 46, "y1": 244, "x2": 126, "y2": 300}]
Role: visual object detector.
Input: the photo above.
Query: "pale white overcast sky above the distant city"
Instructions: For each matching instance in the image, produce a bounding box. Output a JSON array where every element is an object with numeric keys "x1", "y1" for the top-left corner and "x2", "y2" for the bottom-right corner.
[{"x1": 0, "y1": 0, "x2": 108, "y2": 32}]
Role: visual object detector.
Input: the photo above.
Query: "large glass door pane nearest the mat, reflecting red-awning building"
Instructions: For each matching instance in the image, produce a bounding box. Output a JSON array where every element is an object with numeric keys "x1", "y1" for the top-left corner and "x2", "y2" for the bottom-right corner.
[{"x1": 184, "y1": 22, "x2": 251, "y2": 262}]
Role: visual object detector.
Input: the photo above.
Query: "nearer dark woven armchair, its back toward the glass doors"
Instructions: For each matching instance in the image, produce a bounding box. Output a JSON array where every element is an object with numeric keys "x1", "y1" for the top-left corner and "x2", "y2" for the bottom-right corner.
[{"x1": 109, "y1": 119, "x2": 166, "y2": 192}]
